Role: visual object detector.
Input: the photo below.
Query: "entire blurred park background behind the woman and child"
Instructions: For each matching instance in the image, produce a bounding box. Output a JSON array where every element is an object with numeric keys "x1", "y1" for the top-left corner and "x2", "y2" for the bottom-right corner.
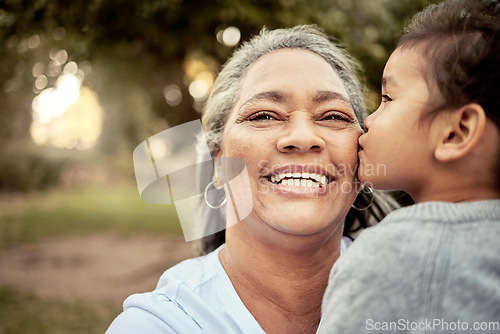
[{"x1": 0, "y1": 0, "x2": 437, "y2": 334}]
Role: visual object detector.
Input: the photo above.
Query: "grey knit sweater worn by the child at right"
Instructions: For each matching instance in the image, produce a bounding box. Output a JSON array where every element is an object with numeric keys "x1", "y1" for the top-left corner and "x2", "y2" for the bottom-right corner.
[{"x1": 319, "y1": 200, "x2": 500, "y2": 334}]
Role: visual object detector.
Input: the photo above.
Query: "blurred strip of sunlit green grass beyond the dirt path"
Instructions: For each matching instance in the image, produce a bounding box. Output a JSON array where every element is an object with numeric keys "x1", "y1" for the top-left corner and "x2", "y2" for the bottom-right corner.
[{"x1": 0, "y1": 185, "x2": 182, "y2": 253}]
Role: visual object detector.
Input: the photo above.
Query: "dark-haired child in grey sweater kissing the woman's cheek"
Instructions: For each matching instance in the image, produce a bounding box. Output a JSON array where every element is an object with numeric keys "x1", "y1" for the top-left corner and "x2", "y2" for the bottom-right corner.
[{"x1": 320, "y1": 0, "x2": 500, "y2": 334}]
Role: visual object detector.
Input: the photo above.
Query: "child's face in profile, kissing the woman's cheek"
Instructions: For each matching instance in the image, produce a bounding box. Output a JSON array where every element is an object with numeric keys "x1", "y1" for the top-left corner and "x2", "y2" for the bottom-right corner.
[{"x1": 359, "y1": 48, "x2": 439, "y2": 196}]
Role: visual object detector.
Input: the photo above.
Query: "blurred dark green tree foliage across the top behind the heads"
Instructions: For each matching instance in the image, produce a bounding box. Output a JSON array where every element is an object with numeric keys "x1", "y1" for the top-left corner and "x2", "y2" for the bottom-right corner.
[{"x1": 0, "y1": 0, "x2": 436, "y2": 190}]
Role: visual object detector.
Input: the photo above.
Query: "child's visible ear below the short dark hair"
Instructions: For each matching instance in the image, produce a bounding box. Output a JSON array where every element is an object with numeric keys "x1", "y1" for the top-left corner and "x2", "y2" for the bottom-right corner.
[{"x1": 434, "y1": 103, "x2": 486, "y2": 162}]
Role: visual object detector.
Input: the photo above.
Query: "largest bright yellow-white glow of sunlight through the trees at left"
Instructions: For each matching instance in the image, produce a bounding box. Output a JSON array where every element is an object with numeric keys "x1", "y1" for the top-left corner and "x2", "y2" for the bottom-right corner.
[{"x1": 30, "y1": 54, "x2": 103, "y2": 150}]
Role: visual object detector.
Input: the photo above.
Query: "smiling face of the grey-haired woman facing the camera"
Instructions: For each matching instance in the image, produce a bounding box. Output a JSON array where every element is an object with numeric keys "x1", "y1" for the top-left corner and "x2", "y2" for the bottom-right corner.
[{"x1": 217, "y1": 49, "x2": 362, "y2": 235}]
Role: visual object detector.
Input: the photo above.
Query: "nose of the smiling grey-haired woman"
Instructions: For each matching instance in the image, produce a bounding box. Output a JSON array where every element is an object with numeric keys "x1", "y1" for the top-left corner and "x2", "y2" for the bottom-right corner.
[{"x1": 277, "y1": 117, "x2": 325, "y2": 153}]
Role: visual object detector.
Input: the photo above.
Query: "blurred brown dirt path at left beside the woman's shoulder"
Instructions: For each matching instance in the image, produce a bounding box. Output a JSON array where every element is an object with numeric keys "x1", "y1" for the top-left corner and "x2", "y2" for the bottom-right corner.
[{"x1": 0, "y1": 235, "x2": 193, "y2": 304}]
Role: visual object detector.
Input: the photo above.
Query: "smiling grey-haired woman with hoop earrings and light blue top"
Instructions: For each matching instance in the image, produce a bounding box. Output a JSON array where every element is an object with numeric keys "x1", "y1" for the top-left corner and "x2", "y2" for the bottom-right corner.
[{"x1": 108, "y1": 26, "x2": 391, "y2": 333}]
